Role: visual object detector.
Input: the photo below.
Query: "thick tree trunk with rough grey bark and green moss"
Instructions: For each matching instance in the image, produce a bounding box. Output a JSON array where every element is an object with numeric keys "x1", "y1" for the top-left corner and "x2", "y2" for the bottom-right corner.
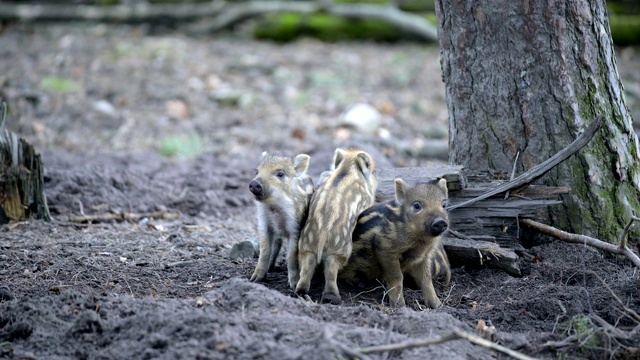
[{"x1": 436, "y1": 0, "x2": 640, "y2": 242}]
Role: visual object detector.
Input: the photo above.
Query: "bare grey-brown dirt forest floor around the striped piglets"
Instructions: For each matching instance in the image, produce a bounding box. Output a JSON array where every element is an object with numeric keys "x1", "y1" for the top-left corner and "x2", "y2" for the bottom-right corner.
[{"x1": 0, "y1": 24, "x2": 640, "y2": 359}]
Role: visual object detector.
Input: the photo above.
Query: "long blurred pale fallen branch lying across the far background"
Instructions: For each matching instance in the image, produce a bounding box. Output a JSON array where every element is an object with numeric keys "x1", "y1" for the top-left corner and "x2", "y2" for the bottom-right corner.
[{"x1": 0, "y1": 0, "x2": 438, "y2": 41}]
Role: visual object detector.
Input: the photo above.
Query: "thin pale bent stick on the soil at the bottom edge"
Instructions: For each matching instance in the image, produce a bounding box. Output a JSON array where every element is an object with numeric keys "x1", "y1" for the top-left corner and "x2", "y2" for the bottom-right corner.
[{"x1": 354, "y1": 328, "x2": 534, "y2": 360}]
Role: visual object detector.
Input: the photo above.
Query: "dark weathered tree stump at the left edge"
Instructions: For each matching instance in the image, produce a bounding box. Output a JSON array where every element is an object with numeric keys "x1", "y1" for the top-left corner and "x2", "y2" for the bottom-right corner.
[{"x1": 0, "y1": 105, "x2": 51, "y2": 225}]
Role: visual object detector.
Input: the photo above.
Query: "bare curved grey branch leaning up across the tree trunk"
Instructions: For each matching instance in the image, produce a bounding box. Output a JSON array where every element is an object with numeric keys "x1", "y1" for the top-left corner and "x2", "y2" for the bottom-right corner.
[{"x1": 447, "y1": 116, "x2": 602, "y2": 211}]
